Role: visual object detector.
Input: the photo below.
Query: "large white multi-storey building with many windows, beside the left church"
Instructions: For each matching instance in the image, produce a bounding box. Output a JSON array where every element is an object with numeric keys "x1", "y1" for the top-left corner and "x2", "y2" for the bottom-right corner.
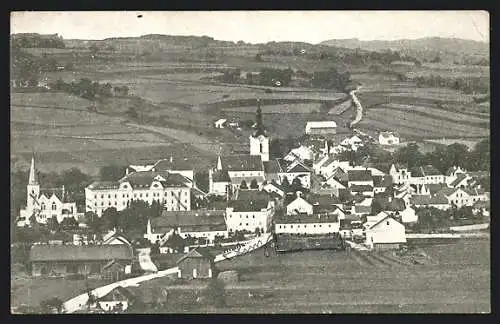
[{"x1": 85, "y1": 170, "x2": 192, "y2": 216}]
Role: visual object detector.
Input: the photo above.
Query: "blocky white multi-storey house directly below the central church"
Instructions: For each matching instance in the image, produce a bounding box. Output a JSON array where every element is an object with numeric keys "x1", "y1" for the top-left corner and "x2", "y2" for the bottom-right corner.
[{"x1": 226, "y1": 191, "x2": 275, "y2": 233}]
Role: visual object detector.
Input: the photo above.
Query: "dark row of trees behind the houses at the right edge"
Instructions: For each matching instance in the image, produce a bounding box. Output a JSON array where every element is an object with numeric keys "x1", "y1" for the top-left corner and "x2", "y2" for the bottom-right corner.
[{"x1": 339, "y1": 139, "x2": 491, "y2": 174}]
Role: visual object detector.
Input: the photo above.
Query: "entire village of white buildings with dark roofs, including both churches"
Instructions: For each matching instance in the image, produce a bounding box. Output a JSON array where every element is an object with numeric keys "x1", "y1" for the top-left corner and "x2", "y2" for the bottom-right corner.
[{"x1": 13, "y1": 102, "x2": 490, "y2": 312}]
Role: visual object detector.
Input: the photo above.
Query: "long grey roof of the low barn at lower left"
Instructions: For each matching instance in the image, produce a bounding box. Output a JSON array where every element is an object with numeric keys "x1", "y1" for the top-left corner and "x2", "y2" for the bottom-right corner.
[{"x1": 30, "y1": 245, "x2": 133, "y2": 261}]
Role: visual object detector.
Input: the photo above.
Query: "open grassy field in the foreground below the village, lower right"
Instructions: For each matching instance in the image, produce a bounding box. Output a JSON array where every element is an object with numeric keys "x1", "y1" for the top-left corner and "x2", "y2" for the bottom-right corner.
[{"x1": 121, "y1": 240, "x2": 491, "y2": 314}]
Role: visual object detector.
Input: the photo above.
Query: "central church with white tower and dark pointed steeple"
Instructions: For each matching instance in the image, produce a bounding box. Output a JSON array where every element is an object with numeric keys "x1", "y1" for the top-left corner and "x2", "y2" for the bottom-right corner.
[{"x1": 209, "y1": 100, "x2": 269, "y2": 195}]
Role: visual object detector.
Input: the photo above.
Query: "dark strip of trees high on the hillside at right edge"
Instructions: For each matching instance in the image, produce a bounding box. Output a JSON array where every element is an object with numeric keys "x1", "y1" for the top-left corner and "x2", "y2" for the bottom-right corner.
[{"x1": 415, "y1": 74, "x2": 490, "y2": 94}]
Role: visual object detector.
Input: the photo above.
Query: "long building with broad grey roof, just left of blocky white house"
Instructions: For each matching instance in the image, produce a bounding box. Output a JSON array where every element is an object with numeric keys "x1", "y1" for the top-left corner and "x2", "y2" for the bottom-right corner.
[{"x1": 144, "y1": 209, "x2": 229, "y2": 244}]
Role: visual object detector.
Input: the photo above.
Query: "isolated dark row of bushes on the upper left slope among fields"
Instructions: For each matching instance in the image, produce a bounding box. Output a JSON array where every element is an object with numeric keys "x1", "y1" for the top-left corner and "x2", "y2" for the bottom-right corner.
[{"x1": 49, "y1": 78, "x2": 129, "y2": 100}]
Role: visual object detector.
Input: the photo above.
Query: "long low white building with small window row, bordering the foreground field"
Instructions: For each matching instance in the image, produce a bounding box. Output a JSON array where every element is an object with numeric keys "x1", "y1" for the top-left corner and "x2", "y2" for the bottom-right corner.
[{"x1": 274, "y1": 213, "x2": 340, "y2": 235}]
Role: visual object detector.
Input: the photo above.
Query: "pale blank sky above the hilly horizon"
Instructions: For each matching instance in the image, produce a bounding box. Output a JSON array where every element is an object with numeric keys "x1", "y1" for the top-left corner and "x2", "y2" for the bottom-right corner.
[{"x1": 11, "y1": 11, "x2": 490, "y2": 44}]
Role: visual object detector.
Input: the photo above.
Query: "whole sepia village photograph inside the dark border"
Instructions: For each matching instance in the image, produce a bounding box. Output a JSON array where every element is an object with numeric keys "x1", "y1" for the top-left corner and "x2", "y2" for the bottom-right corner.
[{"x1": 9, "y1": 10, "x2": 491, "y2": 314}]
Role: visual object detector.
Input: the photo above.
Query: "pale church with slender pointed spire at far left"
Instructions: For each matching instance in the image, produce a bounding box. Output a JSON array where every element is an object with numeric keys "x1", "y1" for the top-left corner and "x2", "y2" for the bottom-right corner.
[{"x1": 17, "y1": 156, "x2": 78, "y2": 227}]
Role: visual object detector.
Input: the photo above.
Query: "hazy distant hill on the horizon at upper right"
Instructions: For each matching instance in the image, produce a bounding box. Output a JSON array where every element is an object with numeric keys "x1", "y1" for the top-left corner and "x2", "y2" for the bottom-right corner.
[{"x1": 320, "y1": 37, "x2": 489, "y2": 63}]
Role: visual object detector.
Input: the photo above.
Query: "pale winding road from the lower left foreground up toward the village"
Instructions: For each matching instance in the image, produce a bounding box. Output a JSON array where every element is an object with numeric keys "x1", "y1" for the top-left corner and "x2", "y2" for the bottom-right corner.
[{"x1": 63, "y1": 233, "x2": 272, "y2": 313}]
